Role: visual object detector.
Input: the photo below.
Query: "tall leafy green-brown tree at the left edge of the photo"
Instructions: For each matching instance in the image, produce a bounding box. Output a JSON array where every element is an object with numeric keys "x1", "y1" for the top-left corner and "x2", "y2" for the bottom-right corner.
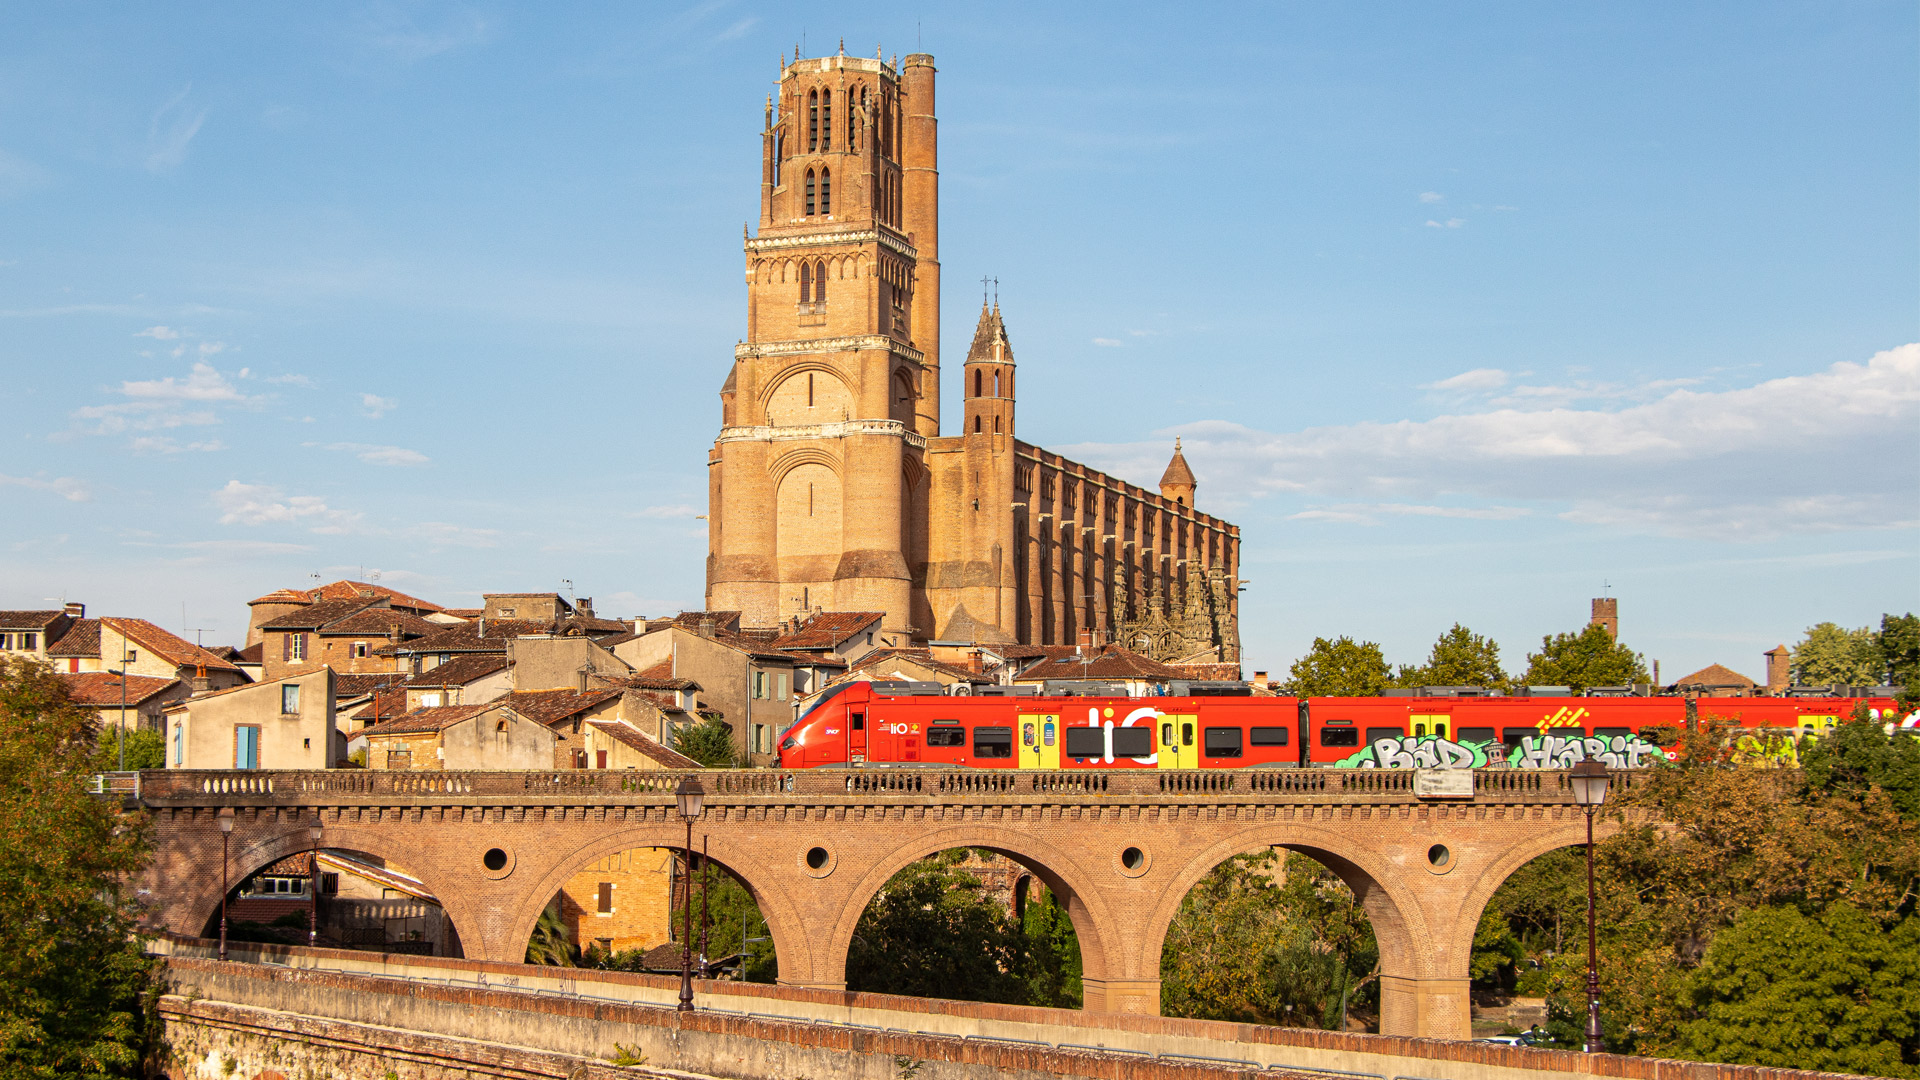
[{"x1": 0, "y1": 657, "x2": 157, "y2": 1080}]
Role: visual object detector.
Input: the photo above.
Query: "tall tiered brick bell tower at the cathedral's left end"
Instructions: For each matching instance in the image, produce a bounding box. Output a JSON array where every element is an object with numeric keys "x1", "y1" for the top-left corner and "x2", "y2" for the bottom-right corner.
[{"x1": 707, "y1": 46, "x2": 941, "y2": 630}]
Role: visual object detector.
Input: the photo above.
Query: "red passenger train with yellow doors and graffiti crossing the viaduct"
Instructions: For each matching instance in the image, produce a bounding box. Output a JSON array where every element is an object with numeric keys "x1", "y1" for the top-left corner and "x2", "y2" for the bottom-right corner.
[{"x1": 780, "y1": 682, "x2": 1912, "y2": 769}]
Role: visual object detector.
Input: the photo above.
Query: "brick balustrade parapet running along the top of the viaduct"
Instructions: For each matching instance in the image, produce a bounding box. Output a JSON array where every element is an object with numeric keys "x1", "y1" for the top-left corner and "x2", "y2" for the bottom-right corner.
[{"x1": 138, "y1": 769, "x2": 1644, "y2": 805}]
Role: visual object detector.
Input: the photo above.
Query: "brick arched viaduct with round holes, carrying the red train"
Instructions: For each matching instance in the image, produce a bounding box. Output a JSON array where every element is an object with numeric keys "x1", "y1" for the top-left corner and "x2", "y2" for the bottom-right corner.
[{"x1": 138, "y1": 769, "x2": 1636, "y2": 1038}]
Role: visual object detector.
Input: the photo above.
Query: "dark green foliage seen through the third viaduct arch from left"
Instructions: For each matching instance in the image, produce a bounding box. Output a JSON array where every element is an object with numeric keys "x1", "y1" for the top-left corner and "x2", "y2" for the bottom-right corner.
[{"x1": 847, "y1": 849, "x2": 1031, "y2": 1005}]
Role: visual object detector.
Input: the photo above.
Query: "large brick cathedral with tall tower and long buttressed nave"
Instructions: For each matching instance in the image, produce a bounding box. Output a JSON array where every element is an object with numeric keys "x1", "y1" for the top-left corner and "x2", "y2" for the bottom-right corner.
[{"x1": 707, "y1": 48, "x2": 1240, "y2": 663}]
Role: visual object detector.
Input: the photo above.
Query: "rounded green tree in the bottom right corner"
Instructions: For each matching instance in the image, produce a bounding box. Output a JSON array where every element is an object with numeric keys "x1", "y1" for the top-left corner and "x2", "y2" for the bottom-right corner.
[{"x1": 1684, "y1": 903, "x2": 1920, "y2": 1076}]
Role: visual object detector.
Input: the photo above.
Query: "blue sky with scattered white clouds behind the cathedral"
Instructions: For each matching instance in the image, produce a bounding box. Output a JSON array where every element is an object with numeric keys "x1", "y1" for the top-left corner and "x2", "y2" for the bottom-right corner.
[{"x1": 0, "y1": 2, "x2": 1920, "y2": 678}]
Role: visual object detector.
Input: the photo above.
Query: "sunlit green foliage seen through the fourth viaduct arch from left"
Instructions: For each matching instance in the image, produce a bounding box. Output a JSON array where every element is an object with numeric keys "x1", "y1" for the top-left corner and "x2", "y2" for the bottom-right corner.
[{"x1": 1160, "y1": 851, "x2": 1379, "y2": 1028}]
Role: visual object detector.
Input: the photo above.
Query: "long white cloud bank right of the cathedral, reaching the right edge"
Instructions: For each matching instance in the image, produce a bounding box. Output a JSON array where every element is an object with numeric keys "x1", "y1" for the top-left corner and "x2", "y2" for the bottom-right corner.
[{"x1": 1062, "y1": 344, "x2": 1920, "y2": 540}]
